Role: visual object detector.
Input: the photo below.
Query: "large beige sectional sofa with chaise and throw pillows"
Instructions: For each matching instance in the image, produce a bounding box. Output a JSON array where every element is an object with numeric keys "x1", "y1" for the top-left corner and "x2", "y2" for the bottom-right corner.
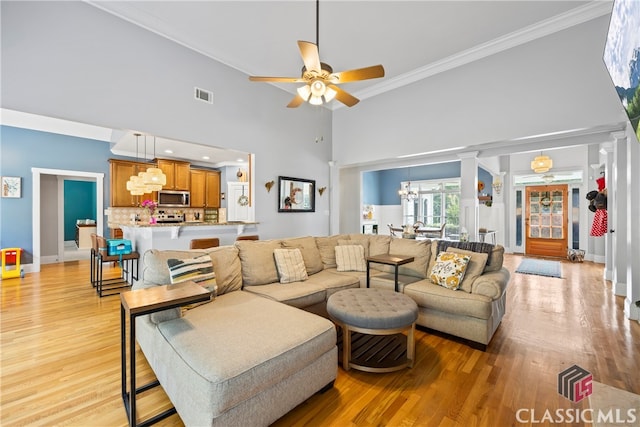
[{"x1": 133, "y1": 234, "x2": 509, "y2": 425}]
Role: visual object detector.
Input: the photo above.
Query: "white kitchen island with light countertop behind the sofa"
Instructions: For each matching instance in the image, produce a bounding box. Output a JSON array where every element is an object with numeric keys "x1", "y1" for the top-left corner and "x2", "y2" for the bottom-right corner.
[{"x1": 109, "y1": 222, "x2": 258, "y2": 256}]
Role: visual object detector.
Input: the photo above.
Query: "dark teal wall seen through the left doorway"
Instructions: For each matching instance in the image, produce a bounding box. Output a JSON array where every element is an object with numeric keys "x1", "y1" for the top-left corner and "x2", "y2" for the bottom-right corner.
[{"x1": 64, "y1": 180, "x2": 96, "y2": 241}]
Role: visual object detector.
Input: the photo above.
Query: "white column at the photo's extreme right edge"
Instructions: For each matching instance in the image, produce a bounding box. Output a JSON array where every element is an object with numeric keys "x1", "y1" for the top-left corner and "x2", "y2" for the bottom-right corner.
[{"x1": 624, "y1": 130, "x2": 640, "y2": 320}]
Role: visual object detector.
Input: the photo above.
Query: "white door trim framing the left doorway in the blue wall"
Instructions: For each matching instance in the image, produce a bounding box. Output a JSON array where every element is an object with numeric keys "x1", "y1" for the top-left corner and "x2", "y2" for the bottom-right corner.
[{"x1": 30, "y1": 168, "x2": 104, "y2": 273}]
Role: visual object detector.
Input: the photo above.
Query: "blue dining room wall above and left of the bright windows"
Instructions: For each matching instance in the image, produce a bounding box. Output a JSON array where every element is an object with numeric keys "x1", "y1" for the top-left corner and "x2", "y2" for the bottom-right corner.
[{"x1": 362, "y1": 161, "x2": 460, "y2": 205}]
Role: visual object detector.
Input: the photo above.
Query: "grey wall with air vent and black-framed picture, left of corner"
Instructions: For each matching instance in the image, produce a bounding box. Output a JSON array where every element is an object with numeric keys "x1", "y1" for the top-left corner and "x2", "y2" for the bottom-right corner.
[{"x1": 0, "y1": 2, "x2": 332, "y2": 238}]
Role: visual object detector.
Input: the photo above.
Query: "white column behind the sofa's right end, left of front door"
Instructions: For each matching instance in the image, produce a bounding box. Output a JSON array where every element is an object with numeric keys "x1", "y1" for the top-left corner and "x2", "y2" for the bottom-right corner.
[{"x1": 458, "y1": 151, "x2": 479, "y2": 242}]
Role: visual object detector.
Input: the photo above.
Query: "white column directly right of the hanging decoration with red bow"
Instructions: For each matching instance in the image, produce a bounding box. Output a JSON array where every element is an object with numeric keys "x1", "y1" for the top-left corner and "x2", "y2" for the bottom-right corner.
[{"x1": 605, "y1": 132, "x2": 628, "y2": 296}]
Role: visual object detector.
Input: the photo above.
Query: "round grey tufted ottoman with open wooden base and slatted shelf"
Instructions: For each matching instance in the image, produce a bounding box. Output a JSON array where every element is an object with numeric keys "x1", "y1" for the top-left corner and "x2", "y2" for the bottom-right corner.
[{"x1": 327, "y1": 288, "x2": 418, "y2": 372}]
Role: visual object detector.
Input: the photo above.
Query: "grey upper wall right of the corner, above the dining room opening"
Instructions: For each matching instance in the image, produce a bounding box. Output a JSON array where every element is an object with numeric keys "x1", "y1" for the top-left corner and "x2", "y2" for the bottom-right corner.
[{"x1": 333, "y1": 17, "x2": 625, "y2": 165}]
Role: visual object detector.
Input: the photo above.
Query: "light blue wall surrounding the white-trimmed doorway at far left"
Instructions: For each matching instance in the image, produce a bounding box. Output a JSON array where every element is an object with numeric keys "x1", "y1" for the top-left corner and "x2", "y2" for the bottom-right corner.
[{"x1": 0, "y1": 126, "x2": 116, "y2": 263}]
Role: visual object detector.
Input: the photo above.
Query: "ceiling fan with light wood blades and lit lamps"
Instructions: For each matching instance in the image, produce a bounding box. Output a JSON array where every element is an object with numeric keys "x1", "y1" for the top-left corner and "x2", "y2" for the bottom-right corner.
[{"x1": 249, "y1": 0, "x2": 384, "y2": 108}]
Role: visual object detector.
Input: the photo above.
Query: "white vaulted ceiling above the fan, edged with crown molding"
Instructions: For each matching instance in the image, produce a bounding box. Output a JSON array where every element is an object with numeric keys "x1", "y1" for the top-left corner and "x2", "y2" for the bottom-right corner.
[{"x1": 89, "y1": 0, "x2": 612, "y2": 108}]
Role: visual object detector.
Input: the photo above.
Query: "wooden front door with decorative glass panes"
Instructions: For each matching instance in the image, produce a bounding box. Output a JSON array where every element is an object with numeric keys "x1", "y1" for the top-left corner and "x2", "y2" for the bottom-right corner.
[{"x1": 525, "y1": 184, "x2": 569, "y2": 258}]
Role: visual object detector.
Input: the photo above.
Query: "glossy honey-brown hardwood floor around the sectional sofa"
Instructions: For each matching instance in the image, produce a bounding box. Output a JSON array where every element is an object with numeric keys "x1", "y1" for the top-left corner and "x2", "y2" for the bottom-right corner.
[{"x1": 0, "y1": 255, "x2": 640, "y2": 427}]
